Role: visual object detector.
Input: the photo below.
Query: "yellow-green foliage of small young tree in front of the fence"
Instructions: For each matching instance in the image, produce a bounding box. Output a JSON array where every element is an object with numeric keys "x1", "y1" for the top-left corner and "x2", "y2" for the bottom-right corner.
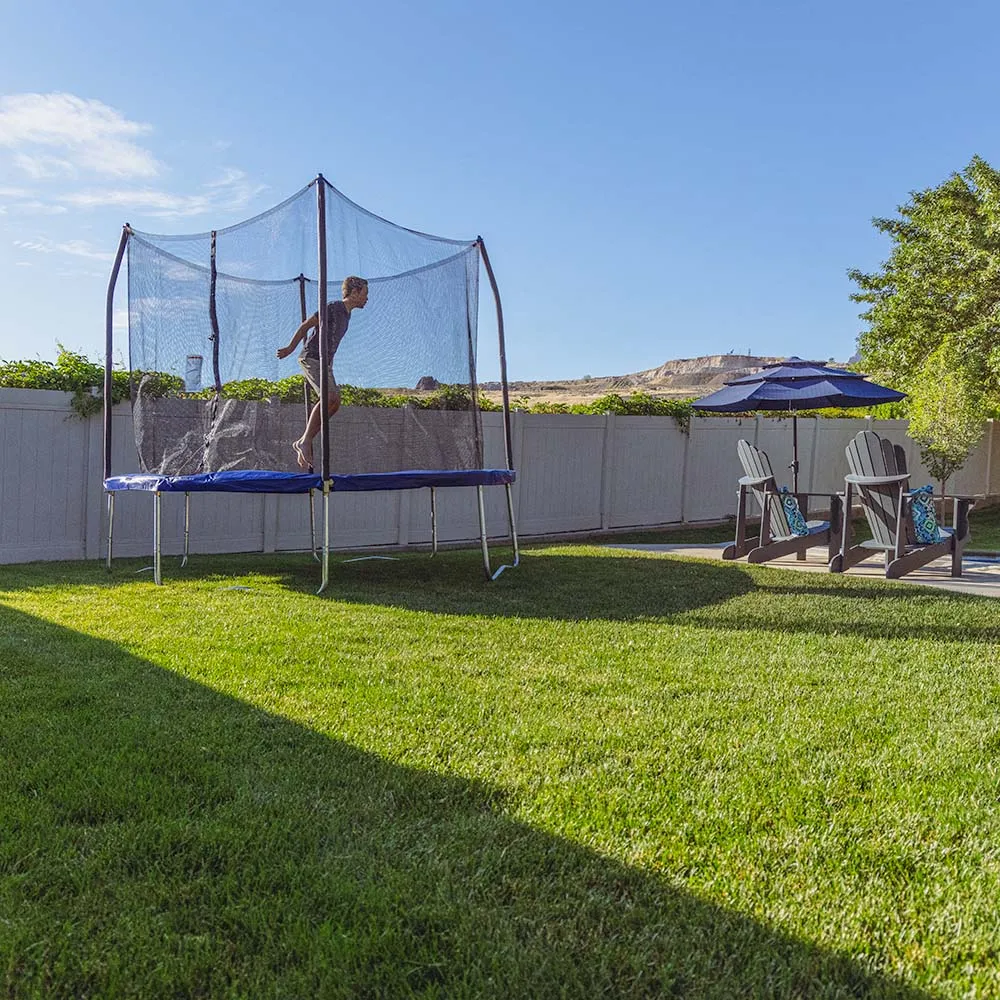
[{"x1": 909, "y1": 341, "x2": 986, "y2": 498}]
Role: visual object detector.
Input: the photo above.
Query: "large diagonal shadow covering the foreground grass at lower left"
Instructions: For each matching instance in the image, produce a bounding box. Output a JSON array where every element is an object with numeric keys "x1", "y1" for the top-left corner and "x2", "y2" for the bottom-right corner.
[{"x1": 0, "y1": 607, "x2": 926, "y2": 1000}]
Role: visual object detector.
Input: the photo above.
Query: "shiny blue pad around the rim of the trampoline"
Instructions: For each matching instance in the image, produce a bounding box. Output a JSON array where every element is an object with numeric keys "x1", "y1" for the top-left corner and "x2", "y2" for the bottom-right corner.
[{"x1": 104, "y1": 469, "x2": 516, "y2": 493}]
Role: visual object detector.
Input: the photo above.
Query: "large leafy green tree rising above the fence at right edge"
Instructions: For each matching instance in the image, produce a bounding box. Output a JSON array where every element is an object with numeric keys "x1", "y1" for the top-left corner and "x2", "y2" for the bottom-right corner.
[{"x1": 848, "y1": 156, "x2": 1000, "y2": 412}]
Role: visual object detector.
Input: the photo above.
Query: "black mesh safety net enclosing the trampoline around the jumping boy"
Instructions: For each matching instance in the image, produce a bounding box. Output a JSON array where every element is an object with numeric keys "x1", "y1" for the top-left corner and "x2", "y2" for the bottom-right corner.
[{"x1": 128, "y1": 181, "x2": 483, "y2": 475}]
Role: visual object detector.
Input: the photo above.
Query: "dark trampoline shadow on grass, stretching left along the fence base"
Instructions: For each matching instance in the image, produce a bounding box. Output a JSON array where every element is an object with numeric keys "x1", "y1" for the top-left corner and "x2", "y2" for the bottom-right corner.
[{"x1": 0, "y1": 549, "x2": 755, "y2": 621}]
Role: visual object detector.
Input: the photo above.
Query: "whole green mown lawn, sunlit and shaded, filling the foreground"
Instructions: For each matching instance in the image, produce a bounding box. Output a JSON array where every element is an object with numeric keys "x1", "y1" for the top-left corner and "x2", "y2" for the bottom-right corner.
[{"x1": 0, "y1": 545, "x2": 1000, "y2": 1000}]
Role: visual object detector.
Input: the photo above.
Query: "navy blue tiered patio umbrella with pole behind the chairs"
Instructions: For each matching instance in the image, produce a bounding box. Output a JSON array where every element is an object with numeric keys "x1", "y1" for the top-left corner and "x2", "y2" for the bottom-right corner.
[{"x1": 691, "y1": 358, "x2": 906, "y2": 491}]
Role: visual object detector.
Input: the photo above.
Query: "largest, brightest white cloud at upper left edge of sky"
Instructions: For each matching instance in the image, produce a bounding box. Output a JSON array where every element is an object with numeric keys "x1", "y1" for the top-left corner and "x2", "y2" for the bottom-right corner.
[{"x1": 0, "y1": 93, "x2": 160, "y2": 178}]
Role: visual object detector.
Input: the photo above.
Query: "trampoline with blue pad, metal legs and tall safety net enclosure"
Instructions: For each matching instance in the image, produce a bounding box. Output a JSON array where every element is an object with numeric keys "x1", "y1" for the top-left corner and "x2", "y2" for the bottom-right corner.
[{"x1": 104, "y1": 175, "x2": 519, "y2": 592}]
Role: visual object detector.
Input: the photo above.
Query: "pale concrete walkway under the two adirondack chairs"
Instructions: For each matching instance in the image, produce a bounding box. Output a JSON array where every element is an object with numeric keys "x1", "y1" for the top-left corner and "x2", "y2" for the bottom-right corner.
[{"x1": 607, "y1": 542, "x2": 1000, "y2": 597}]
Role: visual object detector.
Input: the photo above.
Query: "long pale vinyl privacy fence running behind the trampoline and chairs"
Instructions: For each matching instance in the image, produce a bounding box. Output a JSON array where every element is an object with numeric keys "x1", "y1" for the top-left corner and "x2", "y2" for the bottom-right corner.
[{"x1": 0, "y1": 389, "x2": 1000, "y2": 563}]
